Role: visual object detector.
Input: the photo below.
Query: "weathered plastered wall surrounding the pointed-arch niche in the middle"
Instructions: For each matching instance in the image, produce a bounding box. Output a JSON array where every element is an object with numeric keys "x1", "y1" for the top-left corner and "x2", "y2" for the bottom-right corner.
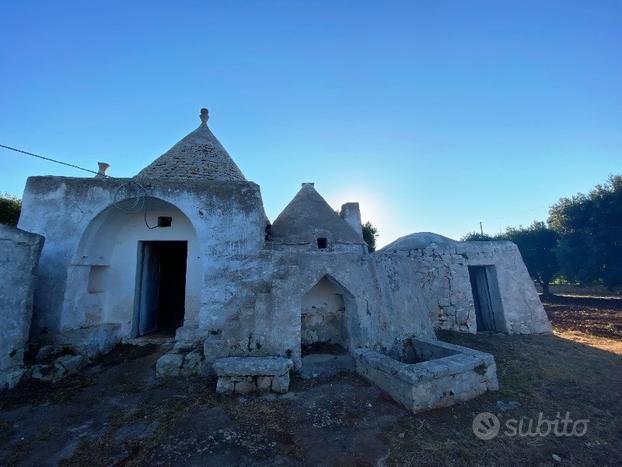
[{"x1": 198, "y1": 244, "x2": 434, "y2": 367}]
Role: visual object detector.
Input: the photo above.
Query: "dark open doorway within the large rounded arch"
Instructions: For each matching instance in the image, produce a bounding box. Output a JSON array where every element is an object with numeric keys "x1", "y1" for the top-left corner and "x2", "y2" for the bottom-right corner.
[{"x1": 134, "y1": 241, "x2": 188, "y2": 336}]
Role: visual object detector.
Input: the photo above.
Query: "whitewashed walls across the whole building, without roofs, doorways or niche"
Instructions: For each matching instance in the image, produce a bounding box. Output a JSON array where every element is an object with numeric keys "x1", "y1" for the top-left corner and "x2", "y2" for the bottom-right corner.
[{"x1": 15, "y1": 177, "x2": 550, "y2": 367}]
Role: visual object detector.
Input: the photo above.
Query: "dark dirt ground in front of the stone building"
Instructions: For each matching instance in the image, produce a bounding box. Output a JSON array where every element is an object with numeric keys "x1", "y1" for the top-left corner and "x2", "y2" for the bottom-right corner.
[{"x1": 0, "y1": 298, "x2": 622, "y2": 466}]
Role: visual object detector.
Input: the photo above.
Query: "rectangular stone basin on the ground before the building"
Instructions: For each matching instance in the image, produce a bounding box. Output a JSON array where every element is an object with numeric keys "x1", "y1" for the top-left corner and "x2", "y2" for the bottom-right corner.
[{"x1": 354, "y1": 339, "x2": 499, "y2": 413}]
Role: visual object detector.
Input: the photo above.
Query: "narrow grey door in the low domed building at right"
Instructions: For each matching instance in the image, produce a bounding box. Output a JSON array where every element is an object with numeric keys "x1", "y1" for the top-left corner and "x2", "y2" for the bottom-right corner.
[{"x1": 469, "y1": 266, "x2": 503, "y2": 331}]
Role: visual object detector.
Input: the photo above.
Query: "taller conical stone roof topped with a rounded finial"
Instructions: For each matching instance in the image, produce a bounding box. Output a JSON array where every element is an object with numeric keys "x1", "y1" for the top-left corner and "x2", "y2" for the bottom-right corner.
[{"x1": 136, "y1": 109, "x2": 246, "y2": 182}]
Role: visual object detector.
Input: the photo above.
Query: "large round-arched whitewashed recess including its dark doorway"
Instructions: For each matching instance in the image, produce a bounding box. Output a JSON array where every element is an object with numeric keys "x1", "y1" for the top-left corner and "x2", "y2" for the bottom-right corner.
[{"x1": 62, "y1": 197, "x2": 202, "y2": 337}]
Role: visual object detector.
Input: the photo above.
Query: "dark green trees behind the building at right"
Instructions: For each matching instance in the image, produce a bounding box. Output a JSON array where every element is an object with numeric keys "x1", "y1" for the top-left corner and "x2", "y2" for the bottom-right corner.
[{"x1": 461, "y1": 175, "x2": 622, "y2": 295}]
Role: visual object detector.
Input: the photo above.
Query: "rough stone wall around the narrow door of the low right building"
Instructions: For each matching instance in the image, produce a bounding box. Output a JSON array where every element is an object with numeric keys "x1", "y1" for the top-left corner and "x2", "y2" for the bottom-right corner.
[{"x1": 375, "y1": 242, "x2": 551, "y2": 334}]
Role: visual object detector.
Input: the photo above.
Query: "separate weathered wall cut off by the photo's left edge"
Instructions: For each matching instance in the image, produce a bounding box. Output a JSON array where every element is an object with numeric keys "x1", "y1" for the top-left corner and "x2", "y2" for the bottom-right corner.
[{"x1": 0, "y1": 224, "x2": 44, "y2": 389}]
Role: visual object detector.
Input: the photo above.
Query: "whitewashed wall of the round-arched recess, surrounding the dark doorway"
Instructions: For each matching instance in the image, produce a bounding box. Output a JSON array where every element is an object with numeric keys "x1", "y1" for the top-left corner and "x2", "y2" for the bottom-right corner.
[{"x1": 61, "y1": 197, "x2": 202, "y2": 337}]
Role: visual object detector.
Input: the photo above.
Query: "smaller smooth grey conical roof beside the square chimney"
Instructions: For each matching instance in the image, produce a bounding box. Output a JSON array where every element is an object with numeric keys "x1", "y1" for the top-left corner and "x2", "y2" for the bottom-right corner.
[{"x1": 270, "y1": 183, "x2": 363, "y2": 243}]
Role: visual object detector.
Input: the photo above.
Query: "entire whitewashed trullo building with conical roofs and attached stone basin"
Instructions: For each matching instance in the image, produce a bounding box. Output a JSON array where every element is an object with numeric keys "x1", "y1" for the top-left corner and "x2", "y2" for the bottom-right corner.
[{"x1": 3, "y1": 109, "x2": 550, "y2": 411}]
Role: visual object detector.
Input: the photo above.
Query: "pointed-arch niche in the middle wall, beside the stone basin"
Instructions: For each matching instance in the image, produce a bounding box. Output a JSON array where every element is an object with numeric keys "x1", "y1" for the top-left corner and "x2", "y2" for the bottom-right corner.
[{"x1": 300, "y1": 276, "x2": 354, "y2": 377}]
